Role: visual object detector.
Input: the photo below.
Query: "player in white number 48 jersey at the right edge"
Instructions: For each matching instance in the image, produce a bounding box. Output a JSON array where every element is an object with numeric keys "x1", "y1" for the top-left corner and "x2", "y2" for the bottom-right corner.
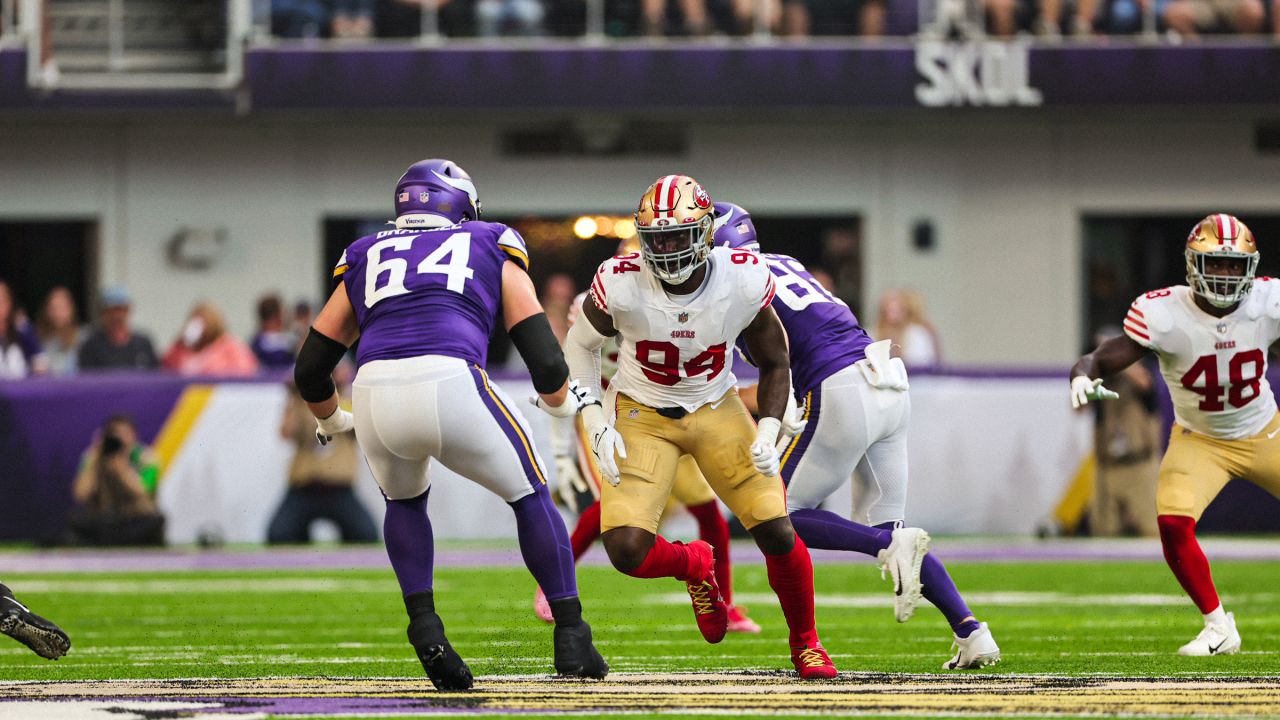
[{"x1": 1071, "y1": 213, "x2": 1280, "y2": 656}]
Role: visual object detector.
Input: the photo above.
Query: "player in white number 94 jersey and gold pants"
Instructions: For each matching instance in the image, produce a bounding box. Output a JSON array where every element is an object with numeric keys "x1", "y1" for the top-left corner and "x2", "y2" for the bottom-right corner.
[{"x1": 552, "y1": 170, "x2": 836, "y2": 679}]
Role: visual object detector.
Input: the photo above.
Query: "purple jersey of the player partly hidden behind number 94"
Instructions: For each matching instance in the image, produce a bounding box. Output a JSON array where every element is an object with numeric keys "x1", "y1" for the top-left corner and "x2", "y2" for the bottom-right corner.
[{"x1": 739, "y1": 252, "x2": 872, "y2": 398}]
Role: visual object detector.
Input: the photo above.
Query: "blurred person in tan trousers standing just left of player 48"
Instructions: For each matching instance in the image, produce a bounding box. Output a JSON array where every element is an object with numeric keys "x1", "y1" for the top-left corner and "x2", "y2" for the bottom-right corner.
[{"x1": 1089, "y1": 325, "x2": 1161, "y2": 537}]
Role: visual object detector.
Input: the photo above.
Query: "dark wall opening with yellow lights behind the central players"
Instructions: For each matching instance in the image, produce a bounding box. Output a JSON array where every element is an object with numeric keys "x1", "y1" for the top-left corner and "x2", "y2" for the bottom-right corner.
[{"x1": 321, "y1": 213, "x2": 863, "y2": 366}]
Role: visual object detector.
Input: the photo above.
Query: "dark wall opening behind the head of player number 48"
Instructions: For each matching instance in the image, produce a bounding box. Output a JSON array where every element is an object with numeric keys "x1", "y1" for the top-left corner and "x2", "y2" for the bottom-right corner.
[{"x1": 1080, "y1": 209, "x2": 1280, "y2": 351}]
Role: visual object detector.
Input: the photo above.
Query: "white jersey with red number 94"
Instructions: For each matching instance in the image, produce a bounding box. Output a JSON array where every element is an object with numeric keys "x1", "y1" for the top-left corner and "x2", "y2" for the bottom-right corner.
[{"x1": 590, "y1": 247, "x2": 774, "y2": 413}]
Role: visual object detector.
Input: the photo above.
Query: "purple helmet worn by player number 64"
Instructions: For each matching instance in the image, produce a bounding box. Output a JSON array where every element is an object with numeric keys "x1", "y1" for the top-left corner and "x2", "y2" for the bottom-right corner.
[{"x1": 396, "y1": 158, "x2": 480, "y2": 227}]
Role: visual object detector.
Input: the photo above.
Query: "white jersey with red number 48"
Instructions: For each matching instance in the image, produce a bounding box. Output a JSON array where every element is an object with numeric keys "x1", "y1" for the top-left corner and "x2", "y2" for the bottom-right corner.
[{"x1": 1124, "y1": 278, "x2": 1280, "y2": 439}]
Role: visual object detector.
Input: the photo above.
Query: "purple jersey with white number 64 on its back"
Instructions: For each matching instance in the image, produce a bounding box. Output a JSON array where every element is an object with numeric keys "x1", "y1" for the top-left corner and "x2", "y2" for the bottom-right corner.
[{"x1": 333, "y1": 220, "x2": 529, "y2": 366}]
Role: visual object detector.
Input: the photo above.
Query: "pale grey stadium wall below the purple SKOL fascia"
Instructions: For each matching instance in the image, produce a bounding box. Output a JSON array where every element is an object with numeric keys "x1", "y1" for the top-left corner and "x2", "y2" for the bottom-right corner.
[{"x1": 0, "y1": 109, "x2": 1280, "y2": 365}]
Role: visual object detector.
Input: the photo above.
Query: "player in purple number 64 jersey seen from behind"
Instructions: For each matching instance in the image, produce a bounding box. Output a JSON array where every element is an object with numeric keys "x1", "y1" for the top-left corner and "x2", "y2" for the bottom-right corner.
[{"x1": 294, "y1": 160, "x2": 608, "y2": 691}]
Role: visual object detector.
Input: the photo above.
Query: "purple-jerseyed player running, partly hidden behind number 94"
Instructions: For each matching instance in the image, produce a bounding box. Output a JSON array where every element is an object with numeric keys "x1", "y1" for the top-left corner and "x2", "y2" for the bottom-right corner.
[{"x1": 713, "y1": 202, "x2": 1000, "y2": 670}]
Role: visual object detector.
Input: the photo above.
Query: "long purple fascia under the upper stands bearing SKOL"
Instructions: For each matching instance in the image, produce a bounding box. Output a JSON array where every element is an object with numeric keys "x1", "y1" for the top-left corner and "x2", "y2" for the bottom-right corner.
[{"x1": 0, "y1": 43, "x2": 1280, "y2": 111}]
